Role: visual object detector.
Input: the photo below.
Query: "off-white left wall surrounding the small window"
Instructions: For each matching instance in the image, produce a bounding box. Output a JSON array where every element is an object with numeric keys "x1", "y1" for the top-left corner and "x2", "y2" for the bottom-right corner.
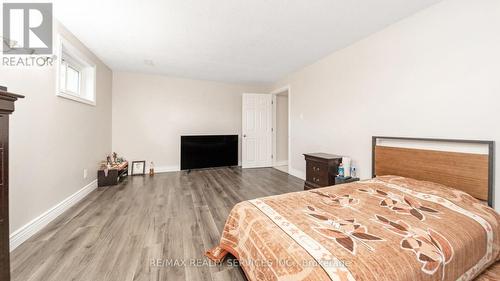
[{"x1": 0, "y1": 23, "x2": 112, "y2": 233}]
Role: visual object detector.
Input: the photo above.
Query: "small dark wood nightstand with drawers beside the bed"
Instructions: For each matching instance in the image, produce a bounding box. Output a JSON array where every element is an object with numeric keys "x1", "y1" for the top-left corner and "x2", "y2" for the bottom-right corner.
[{"x1": 304, "y1": 153, "x2": 342, "y2": 190}]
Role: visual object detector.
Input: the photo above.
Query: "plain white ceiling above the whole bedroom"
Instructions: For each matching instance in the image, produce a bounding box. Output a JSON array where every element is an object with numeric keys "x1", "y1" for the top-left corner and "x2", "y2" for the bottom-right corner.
[{"x1": 54, "y1": 0, "x2": 439, "y2": 83}]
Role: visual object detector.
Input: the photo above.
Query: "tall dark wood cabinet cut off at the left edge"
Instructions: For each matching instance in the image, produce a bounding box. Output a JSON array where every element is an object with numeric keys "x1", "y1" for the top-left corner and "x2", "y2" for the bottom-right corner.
[{"x1": 0, "y1": 87, "x2": 22, "y2": 281}]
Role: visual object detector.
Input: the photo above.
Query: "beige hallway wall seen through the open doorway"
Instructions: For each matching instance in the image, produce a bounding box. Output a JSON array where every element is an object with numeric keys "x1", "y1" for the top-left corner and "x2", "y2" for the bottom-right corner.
[{"x1": 275, "y1": 92, "x2": 288, "y2": 162}]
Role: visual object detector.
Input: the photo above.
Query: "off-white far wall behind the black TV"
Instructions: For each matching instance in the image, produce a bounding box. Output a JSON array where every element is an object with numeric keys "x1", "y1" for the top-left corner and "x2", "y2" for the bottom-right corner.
[{"x1": 113, "y1": 72, "x2": 264, "y2": 171}]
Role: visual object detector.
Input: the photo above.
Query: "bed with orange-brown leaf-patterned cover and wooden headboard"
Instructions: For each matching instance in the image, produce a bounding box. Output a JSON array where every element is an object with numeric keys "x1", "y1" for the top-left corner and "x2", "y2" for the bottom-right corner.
[{"x1": 207, "y1": 137, "x2": 500, "y2": 281}]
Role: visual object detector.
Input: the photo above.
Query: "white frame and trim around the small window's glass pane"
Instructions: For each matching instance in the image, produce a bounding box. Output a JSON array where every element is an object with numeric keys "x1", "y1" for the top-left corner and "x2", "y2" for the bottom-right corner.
[{"x1": 56, "y1": 35, "x2": 97, "y2": 106}]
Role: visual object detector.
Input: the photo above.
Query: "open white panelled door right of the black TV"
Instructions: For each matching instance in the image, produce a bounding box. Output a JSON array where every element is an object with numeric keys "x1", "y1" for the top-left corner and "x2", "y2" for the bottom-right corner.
[{"x1": 241, "y1": 94, "x2": 273, "y2": 168}]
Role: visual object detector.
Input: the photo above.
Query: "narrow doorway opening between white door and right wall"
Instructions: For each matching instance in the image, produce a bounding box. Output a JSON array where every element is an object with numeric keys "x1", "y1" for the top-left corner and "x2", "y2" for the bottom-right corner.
[{"x1": 271, "y1": 87, "x2": 290, "y2": 173}]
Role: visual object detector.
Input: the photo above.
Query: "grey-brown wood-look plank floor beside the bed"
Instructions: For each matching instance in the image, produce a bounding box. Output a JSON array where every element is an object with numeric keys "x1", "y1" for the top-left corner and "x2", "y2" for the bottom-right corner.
[{"x1": 11, "y1": 168, "x2": 303, "y2": 281}]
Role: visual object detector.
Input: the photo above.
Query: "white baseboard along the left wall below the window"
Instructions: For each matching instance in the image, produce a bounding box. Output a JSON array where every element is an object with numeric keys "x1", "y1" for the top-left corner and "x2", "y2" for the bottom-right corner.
[{"x1": 10, "y1": 180, "x2": 97, "y2": 252}]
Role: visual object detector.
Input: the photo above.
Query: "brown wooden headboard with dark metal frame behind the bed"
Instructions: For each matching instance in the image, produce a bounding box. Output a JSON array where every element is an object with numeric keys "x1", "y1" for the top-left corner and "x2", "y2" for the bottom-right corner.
[{"x1": 372, "y1": 136, "x2": 495, "y2": 207}]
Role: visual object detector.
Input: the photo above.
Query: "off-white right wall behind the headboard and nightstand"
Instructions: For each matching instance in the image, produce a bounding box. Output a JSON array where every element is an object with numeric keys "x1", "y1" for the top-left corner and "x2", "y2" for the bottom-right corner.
[{"x1": 274, "y1": 0, "x2": 500, "y2": 210}]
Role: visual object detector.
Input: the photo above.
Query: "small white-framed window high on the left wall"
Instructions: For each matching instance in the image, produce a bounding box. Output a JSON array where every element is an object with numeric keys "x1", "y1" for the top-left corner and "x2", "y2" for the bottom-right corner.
[{"x1": 57, "y1": 35, "x2": 96, "y2": 105}]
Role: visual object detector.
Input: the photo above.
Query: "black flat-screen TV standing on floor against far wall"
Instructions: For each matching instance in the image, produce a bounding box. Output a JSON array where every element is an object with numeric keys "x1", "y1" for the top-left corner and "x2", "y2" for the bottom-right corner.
[{"x1": 181, "y1": 135, "x2": 238, "y2": 170}]
